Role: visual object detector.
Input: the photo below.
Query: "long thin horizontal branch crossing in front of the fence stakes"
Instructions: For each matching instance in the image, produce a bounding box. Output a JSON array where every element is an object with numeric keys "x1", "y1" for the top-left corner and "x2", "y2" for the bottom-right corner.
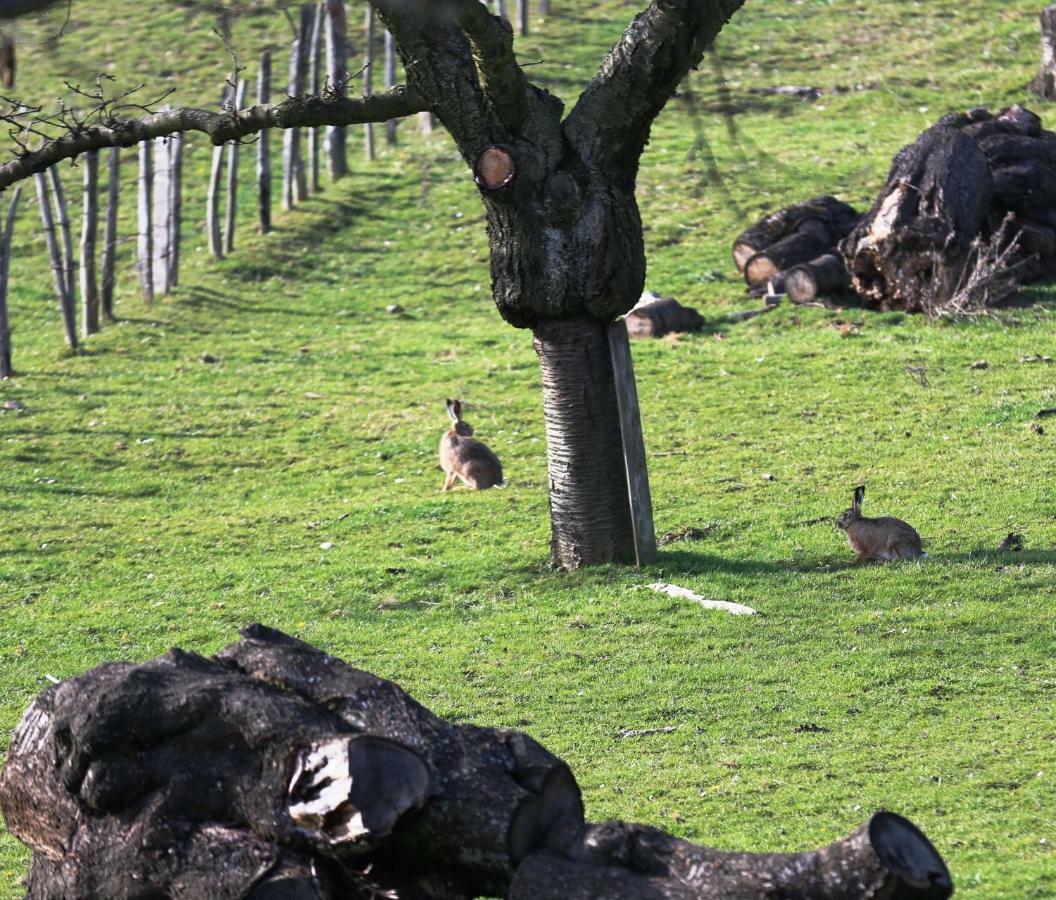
[{"x1": 0, "y1": 87, "x2": 429, "y2": 190}]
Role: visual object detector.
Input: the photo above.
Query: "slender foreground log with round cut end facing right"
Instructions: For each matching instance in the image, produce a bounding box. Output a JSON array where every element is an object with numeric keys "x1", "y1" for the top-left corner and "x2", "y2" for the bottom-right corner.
[{"x1": 509, "y1": 812, "x2": 954, "y2": 900}]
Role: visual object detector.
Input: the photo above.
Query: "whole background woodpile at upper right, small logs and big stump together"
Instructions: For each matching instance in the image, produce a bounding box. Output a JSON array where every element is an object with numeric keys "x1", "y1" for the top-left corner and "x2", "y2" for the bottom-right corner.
[{"x1": 734, "y1": 106, "x2": 1056, "y2": 313}]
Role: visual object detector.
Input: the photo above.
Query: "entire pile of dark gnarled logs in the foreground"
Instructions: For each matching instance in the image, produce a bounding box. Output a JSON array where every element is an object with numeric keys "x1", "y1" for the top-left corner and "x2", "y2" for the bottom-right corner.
[{"x1": 0, "y1": 625, "x2": 953, "y2": 900}]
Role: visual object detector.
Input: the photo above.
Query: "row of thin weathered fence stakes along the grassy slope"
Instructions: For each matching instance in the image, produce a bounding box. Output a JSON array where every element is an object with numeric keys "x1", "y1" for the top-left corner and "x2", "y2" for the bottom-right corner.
[{"x1": 0, "y1": 0, "x2": 424, "y2": 378}]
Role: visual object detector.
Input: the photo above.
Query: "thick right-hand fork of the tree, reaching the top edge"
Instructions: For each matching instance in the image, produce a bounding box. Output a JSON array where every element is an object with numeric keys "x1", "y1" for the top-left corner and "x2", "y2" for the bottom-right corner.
[{"x1": 565, "y1": 0, "x2": 744, "y2": 183}]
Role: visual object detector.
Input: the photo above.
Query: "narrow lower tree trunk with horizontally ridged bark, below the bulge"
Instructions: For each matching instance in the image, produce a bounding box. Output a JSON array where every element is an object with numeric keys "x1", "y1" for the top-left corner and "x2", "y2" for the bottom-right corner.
[{"x1": 533, "y1": 319, "x2": 635, "y2": 569}]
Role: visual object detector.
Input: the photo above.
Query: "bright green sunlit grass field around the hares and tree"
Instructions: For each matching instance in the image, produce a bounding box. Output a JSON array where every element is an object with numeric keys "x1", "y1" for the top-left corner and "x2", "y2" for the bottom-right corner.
[{"x1": 0, "y1": 0, "x2": 1056, "y2": 900}]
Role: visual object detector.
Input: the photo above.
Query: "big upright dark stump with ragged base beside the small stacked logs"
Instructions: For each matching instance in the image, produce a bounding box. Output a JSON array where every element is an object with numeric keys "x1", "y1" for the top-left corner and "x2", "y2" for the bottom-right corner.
[{"x1": 841, "y1": 126, "x2": 993, "y2": 311}]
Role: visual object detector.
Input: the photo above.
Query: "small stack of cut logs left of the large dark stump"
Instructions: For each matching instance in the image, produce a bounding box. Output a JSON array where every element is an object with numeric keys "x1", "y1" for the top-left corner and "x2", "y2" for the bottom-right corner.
[{"x1": 733, "y1": 196, "x2": 859, "y2": 302}]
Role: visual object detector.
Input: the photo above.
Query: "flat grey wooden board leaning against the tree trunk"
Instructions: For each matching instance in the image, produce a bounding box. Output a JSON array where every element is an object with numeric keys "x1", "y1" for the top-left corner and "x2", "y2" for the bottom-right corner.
[{"x1": 608, "y1": 319, "x2": 657, "y2": 566}]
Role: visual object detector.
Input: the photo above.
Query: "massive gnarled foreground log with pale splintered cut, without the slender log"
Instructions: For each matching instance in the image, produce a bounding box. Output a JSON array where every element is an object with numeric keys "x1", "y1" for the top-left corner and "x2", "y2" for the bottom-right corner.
[{"x1": 0, "y1": 626, "x2": 583, "y2": 900}]
